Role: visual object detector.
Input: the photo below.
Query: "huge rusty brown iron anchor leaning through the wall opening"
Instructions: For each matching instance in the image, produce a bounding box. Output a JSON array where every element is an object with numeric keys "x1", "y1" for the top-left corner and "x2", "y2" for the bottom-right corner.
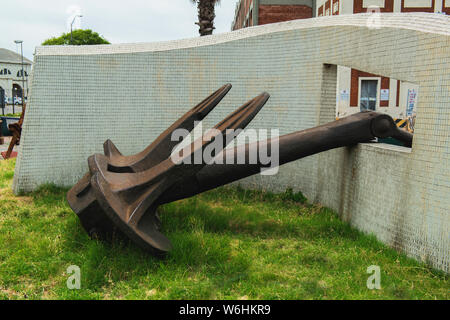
[{"x1": 67, "y1": 84, "x2": 412, "y2": 255}]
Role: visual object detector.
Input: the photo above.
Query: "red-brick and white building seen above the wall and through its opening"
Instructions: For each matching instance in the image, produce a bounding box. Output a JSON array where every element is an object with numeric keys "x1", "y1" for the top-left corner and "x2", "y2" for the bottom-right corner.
[{"x1": 232, "y1": 0, "x2": 450, "y2": 124}]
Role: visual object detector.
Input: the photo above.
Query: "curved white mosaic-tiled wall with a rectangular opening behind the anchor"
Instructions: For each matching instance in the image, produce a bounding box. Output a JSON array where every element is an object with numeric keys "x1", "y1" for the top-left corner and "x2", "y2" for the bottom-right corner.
[{"x1": 13, "y1": 14, "x2": 450, "y2": 272}]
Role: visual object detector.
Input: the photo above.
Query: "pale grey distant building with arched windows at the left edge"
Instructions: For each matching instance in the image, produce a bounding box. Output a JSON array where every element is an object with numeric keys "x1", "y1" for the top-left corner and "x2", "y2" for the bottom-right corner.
[{"x1": 0, "y1": 48, "x2": 32, "y2": 104}]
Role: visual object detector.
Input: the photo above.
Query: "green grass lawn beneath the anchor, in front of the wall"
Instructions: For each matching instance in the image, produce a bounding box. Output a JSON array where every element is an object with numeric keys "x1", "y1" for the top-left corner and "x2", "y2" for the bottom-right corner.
[{"x1": 0, "y1": 160, "x2": 450, "y2": 299}]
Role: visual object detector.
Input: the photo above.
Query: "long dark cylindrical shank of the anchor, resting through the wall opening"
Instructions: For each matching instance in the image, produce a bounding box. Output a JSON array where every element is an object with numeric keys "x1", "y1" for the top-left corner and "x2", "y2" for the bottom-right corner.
[{"x1": 159, "y1": 112, "x2": 412, "y2": 204}]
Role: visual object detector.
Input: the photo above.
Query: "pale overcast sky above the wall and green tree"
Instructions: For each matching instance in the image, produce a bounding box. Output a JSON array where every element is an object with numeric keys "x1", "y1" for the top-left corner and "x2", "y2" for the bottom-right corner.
[{"x1": 0, "y1": 0, "x2": 236, "y2": 60}]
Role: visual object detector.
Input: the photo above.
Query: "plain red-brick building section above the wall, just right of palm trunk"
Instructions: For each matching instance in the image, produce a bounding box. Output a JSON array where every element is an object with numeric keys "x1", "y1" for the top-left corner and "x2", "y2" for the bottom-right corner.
[{"x1": 231, "y1": 0, "x2": 316, "y2": 30}]
